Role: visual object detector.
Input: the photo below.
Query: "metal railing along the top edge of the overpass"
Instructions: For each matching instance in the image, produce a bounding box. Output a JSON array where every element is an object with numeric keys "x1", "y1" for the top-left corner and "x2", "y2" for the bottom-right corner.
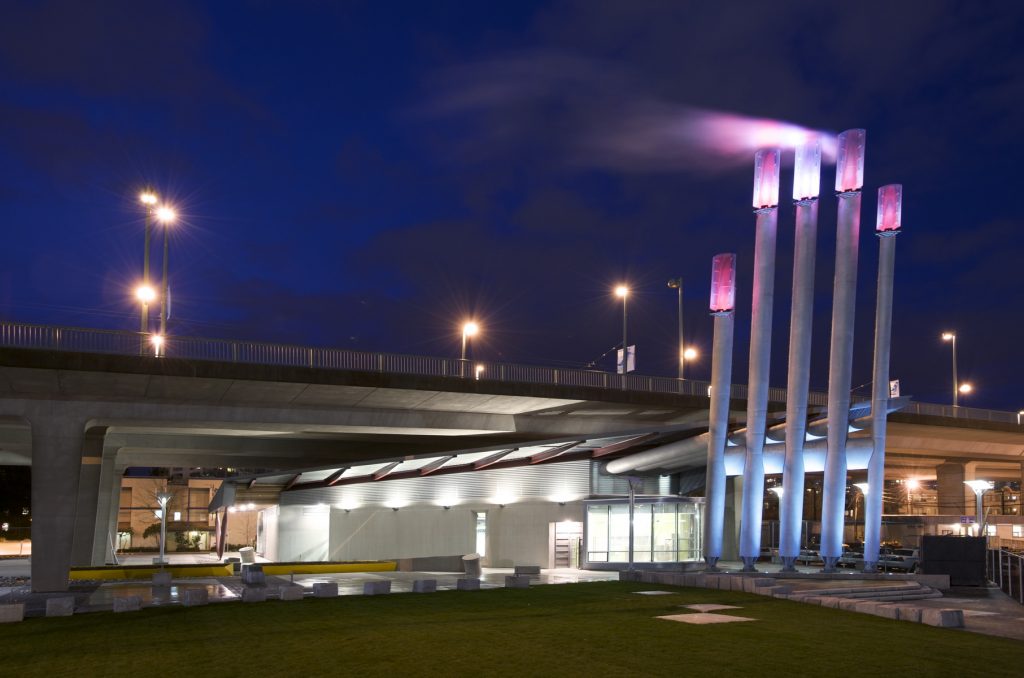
[{"x1": 0, "y1": 323, "x2": 1018, "y2": 422}]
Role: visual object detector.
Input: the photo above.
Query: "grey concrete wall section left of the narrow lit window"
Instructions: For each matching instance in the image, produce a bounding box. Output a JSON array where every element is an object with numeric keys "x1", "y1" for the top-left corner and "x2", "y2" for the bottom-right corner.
[{"x1": 328, "y1": 506, "x2": 476, "y2": 560}]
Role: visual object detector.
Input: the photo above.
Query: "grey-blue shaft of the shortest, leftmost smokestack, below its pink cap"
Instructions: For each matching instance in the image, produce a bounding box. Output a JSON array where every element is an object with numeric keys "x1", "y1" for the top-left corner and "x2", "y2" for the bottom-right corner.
[{"x1": 703, "y1": 313, "x2": 733, "y2": 569}]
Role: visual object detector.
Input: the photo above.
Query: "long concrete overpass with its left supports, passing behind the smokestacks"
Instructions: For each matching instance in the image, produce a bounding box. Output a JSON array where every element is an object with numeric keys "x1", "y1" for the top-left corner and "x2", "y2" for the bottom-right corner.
[{"x1": 0, "y1": 324, "x2": 1024, "y2": 591}]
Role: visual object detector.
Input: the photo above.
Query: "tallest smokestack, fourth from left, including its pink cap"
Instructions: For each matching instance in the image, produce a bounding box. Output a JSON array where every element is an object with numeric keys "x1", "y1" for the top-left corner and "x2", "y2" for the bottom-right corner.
[{"x1": 821, "y1": 129, "x2": 860, "y2": 571}]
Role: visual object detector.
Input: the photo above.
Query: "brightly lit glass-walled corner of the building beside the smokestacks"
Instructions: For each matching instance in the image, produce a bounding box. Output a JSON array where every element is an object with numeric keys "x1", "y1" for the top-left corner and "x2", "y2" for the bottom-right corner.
[{"x1": 585, "y1": 498, "x2": 703, "y2": 566}]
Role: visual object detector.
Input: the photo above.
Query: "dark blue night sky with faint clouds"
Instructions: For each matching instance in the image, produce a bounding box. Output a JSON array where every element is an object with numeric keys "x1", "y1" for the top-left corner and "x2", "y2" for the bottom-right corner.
[{"x1": 0, "y1": 0, "x2": 1024, "y2": 411}]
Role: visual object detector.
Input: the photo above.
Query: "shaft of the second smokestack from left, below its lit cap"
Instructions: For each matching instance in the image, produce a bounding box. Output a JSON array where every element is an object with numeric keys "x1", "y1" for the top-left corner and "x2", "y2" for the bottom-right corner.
[{"x1": 739, "y1": 208, "x2": 778, "y2": 571}]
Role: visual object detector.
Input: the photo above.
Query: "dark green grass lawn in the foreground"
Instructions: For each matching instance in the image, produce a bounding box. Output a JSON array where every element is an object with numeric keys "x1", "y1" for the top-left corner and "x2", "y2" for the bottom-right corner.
[{"x1": 0, "y1": 582, "x2": 1024, "y2": 678}]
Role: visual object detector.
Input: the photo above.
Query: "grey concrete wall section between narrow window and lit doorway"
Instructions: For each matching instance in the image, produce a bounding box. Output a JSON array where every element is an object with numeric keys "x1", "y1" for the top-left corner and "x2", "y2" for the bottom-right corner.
[{"x1": 483, "y1": 502, "x2": 584, "y2": 567}]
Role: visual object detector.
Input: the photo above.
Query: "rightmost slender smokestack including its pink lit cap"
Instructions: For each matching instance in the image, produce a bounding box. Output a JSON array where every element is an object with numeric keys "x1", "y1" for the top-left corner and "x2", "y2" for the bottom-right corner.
[{"x1": 864, "y1": 183, "x2": 903, "y2": 571}]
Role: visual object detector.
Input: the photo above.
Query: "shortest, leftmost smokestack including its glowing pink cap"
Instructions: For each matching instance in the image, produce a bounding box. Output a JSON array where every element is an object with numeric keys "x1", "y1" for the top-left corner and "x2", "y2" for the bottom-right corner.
[{"x1": 703, "y1": 254, "x2": 736, "y2": 570}]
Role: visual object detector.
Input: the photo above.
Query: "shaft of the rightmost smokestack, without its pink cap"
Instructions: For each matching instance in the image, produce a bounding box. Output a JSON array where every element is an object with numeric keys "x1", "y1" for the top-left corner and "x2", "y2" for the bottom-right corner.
[{"x1": 864, "y1": 231, "x2": 896, "y2": 571}]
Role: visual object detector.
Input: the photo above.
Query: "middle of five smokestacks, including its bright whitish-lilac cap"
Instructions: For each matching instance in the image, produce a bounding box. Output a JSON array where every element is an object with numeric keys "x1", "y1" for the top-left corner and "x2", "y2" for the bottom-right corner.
[{"x1": 779, "y1": 136, "x2": 821, "y2": 571}]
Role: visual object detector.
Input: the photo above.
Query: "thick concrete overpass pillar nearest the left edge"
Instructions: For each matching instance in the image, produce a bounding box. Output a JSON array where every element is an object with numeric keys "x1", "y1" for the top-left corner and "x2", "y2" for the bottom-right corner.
[{"x1": 29, "y1": 404, "x2": 85, "y2": 592}]
